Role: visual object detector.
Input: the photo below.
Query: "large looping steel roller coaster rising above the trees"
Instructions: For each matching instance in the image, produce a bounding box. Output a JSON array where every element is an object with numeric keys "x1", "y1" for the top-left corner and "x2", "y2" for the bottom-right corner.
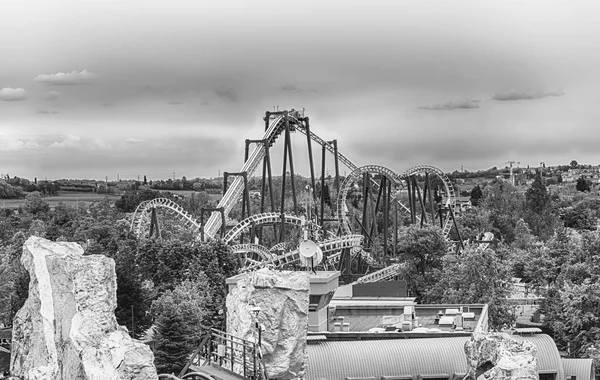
[{"x1": 131, "y1": 109, "x2": 493, "y2": 283}]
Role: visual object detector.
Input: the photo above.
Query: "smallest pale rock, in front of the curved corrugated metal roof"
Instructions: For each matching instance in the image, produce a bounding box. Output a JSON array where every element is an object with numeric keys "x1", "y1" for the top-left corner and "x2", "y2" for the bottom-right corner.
[{"x1": 465, "y1": 333, "x2": 538, "y2": 380}]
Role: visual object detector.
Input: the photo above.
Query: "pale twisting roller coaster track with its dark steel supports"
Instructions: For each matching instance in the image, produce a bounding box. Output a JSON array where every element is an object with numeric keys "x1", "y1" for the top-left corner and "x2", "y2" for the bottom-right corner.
[{"x1": 131, "y1": 109, "x2": 493, "y2": 283}]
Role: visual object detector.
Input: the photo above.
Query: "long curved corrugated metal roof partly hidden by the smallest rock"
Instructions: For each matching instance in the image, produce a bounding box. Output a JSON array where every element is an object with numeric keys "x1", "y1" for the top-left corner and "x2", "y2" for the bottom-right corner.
[{"x1": 306, "y1": 334, "x2": 564, "y2": 380}]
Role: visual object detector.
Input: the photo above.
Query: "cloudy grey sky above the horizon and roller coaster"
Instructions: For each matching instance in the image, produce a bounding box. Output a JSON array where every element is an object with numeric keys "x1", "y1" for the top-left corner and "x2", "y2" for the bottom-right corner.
[{"x1": 0, "y1": 0, "x2": 600, "y2": 180}]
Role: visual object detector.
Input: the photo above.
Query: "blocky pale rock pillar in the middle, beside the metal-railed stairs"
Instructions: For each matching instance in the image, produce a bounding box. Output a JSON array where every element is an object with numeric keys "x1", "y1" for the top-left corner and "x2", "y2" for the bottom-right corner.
[{"x1": 227, "y1": 269, "x2": 310, "y2": 379}]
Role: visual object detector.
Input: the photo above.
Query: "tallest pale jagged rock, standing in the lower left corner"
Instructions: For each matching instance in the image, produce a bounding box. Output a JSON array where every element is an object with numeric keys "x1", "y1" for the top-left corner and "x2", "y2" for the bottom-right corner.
[{"x1": 11, "y1": 237, "x2": 158, "y2": 380}]
